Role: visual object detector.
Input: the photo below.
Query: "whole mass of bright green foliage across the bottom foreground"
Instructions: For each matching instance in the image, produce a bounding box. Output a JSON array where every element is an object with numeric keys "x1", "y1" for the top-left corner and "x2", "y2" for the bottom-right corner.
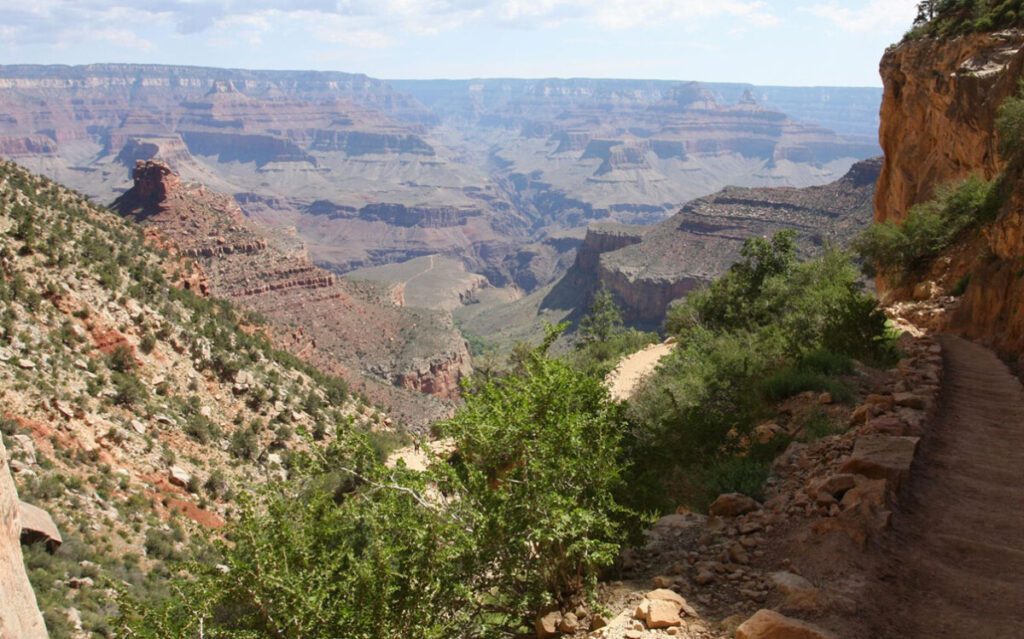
[{"x1": 121, "y1": 335, "x2": 637, "y2": 639}]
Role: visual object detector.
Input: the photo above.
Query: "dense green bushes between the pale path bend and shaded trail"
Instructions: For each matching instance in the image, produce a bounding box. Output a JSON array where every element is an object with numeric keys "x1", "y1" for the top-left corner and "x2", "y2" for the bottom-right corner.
[{"x1": 630, "y1": 231, "x2": 894, "y2": 508}]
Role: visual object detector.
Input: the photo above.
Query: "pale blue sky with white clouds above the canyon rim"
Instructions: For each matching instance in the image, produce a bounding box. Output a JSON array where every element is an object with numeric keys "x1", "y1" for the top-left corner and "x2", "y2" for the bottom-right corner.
[{"x1": 0, "y1": 0, "x2": 916, "y2": 86}]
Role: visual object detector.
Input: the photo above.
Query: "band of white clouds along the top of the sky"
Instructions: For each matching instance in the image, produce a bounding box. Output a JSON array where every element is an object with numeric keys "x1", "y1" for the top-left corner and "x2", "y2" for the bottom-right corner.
[{"x1": 0, "y1": 0, "x2": 778, "y2": 52}]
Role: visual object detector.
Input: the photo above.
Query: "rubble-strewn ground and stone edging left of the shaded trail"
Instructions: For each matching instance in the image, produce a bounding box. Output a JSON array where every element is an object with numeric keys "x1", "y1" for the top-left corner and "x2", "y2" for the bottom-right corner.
[{"x1": 539, "y1": 327, "x2": 943, "y2": 639}]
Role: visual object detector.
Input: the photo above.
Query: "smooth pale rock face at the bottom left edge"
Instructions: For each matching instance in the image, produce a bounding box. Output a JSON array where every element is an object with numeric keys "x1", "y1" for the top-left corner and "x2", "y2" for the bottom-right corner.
[{"x1": 0, "y1": 438, "x2": 47, "y2": 639}]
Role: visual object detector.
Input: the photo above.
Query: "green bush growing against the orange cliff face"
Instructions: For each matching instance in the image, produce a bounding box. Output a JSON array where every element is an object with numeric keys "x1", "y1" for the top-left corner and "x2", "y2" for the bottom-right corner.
[{"x1": 854, "y1": 177, "x2": 1000, "y2": 276}]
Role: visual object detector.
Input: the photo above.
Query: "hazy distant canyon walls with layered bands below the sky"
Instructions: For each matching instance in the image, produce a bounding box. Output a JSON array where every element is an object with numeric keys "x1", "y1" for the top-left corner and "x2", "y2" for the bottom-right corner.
[{"x1": 0, "y1": 65, "x2": 880, "y2": 293}]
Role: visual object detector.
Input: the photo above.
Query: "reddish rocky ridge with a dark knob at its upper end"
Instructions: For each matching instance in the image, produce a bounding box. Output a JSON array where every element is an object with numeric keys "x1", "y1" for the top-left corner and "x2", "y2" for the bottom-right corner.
[{"x1": 115, "y1": 161, "x2": 471, "y2": 427}]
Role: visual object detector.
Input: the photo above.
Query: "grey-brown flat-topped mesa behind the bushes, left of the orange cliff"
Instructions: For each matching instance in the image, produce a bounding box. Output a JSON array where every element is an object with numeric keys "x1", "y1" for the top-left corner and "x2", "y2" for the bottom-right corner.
[{"x1": 593, "y1": 155, "x2": 881, "y2": 325}]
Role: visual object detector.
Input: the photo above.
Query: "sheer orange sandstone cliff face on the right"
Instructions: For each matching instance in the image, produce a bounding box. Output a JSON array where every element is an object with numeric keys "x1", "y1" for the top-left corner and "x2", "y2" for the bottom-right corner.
[{"x1": 876, "y1": 31, "x2": 1024, "y2": 356}]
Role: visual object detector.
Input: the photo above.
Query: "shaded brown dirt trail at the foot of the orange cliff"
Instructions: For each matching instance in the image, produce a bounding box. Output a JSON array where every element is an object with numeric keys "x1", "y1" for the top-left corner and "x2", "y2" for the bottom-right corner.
[{"x1": 869, "y1": 337, "x2": 1024, "y2": 639}]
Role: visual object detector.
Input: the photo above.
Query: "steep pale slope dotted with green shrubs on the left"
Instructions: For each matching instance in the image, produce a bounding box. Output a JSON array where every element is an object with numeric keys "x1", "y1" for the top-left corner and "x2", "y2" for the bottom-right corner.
[{"x1": 0, "y1": 163, "x2": 386, "y2": 639}]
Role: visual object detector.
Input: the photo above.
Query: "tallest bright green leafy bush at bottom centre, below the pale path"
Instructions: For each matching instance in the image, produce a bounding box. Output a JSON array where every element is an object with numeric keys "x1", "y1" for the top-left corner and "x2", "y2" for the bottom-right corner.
[{"x1": 440, "y1": 331, "x2": 632, "y2": 619}]
